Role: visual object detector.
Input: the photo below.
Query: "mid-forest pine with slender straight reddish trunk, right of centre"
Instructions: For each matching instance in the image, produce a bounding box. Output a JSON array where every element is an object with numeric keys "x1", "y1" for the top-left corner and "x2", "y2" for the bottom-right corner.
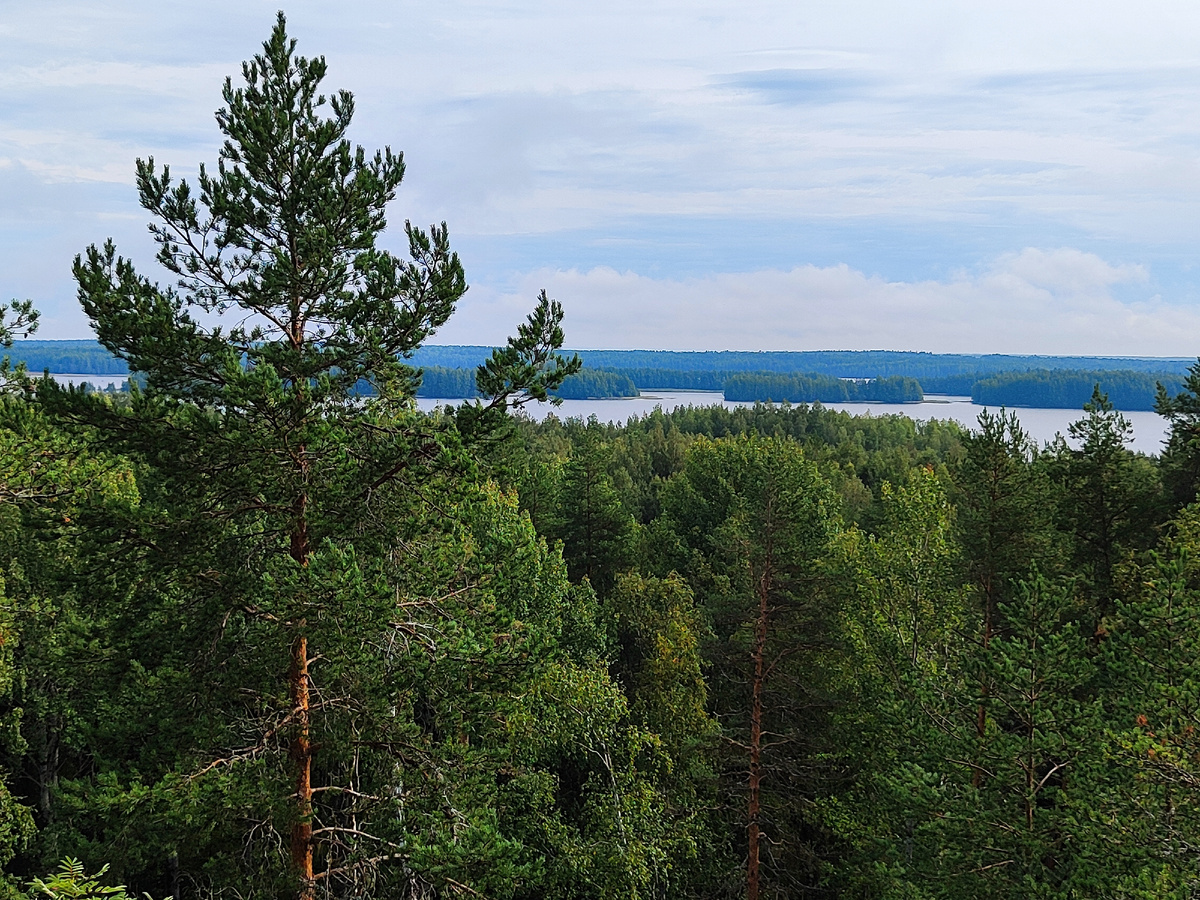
[{"x1": 660, "y1": 437, "x2": 838, "y2": 900}]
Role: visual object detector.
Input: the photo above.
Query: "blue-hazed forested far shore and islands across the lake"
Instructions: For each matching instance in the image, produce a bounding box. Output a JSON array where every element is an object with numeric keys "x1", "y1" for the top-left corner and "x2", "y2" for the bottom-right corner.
[{"x1": 8, "y1": 341, "x2": 1192, "y2": 412}]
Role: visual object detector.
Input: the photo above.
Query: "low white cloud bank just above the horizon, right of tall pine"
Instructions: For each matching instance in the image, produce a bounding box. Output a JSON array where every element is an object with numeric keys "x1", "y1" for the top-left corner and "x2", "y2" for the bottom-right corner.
[{"x1": 437, "y1": 248, "x2": 1200, "y2": 356}]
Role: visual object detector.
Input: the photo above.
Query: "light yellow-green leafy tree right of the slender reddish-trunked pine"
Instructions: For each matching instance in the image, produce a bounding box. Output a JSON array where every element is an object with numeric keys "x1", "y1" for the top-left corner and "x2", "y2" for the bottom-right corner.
[{"x1": 818, "y1": 469, "x2": 968, "y2": 898}]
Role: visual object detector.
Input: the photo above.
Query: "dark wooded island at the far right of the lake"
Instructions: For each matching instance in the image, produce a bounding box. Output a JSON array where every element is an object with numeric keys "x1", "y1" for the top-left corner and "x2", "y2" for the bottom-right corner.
[{"x1": 971, "y1": 368, "x2": 1183, "y2": 412}]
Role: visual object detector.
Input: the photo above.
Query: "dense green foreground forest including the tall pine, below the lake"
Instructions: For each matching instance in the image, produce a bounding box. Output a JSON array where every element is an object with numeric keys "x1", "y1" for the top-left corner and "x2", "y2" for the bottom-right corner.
[{"x1": 16, "y1": 16, "x2": 1200, "y2": 900}]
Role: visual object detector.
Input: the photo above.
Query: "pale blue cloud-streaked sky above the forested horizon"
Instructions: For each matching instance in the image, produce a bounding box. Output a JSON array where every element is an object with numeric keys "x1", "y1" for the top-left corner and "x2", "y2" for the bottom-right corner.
[{"x1": 0, "y1": 0, "x2": 1200, "y2": 356}]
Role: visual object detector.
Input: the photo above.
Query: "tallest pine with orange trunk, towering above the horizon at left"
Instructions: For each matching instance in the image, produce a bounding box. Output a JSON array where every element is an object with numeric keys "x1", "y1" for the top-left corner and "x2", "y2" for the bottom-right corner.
[{"x1": 41, "y1": 13, "x2": 577, "y2": 899}]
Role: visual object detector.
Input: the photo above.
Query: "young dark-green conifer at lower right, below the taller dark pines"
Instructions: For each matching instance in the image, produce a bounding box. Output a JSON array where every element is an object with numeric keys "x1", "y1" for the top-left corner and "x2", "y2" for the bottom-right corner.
[{"x1": 931, "y1": 577, "x2": 1106, "y2": 900}]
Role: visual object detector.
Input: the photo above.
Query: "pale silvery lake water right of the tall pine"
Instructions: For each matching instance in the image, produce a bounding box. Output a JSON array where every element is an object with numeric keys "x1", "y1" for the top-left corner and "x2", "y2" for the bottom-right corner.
[{"x1": 418, "y1": 391, "x2": 1166, "y2": 454}]
